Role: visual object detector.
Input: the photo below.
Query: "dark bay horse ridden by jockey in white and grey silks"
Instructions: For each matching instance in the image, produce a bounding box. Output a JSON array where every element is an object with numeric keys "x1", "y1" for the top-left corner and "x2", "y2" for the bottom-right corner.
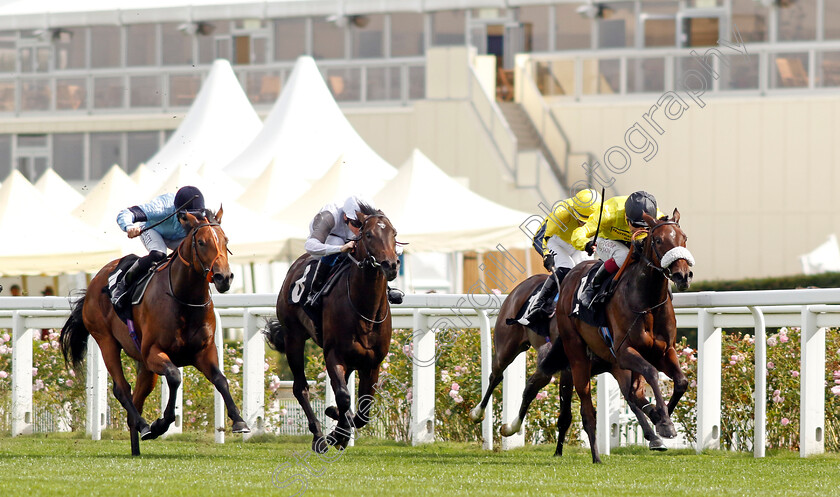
[{"x1": 265, "y1": 206, "x2": 400, "y2": 454}]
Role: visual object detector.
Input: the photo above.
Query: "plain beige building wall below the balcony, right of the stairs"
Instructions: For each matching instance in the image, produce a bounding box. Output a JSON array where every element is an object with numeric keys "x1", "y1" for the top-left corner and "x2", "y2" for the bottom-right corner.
[{"x1": 553, "y1": 94, "x2": 840, "y2": 280}]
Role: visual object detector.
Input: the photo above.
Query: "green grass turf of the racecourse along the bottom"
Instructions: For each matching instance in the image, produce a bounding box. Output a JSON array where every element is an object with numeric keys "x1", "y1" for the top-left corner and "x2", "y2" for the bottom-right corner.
[{"x1": 0, "y1": 433, "x2": 840, "y2": 497}]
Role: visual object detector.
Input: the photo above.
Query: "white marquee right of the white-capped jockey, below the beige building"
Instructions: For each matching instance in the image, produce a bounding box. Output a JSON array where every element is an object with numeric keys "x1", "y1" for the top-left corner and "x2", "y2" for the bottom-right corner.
[{"x1": 373, "y1": 149, "x2": 531, "y2": 252}]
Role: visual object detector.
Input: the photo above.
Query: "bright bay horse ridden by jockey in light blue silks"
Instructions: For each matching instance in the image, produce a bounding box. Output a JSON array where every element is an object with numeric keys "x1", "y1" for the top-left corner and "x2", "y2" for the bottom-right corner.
[{"x1": 60, "y1": 207, "x2": 250, "y2": 456}]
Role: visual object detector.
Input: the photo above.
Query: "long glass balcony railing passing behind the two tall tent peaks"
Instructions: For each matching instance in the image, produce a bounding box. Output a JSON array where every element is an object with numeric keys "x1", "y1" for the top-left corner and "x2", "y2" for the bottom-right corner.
[{"x1": 0, "y1": 57, "x2": 426, "y2": 116}]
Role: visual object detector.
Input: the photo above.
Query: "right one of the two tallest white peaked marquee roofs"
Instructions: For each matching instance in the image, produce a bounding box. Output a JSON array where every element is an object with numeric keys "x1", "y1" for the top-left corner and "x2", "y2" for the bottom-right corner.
[{"x1": 225, "y1": 56, "x2": 390, "y2": 184}]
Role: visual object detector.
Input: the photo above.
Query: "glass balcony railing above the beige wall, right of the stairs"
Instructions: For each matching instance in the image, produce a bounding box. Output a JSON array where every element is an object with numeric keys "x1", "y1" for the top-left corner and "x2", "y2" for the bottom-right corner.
[{"x1": 530, "y1": 41, "x2": 840, "y2": 100}]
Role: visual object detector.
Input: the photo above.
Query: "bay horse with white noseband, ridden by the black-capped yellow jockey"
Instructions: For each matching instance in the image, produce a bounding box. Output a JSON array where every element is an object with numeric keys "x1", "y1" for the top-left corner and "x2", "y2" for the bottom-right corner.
[{"x1": 554, "y1": 209, "x2": 694, "y2": 463}]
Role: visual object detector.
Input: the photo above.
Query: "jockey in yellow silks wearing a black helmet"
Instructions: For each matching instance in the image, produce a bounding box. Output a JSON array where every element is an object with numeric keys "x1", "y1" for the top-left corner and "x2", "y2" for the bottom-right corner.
[{"x1": 571, "y1": 191, "x2": 665, "y2": 307}]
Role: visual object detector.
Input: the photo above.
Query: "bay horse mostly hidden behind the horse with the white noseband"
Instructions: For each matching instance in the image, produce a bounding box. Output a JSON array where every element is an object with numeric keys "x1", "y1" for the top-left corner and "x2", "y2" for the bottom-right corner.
[{"x1": 470, "y1": 274, "x2": 666, "y2": 456}]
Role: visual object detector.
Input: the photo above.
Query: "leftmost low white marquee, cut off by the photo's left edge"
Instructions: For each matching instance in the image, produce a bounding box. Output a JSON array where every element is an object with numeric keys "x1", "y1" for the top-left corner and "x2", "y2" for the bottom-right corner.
[{"x1": 0, "y1": 171, "x2": 120, "y2": 275}]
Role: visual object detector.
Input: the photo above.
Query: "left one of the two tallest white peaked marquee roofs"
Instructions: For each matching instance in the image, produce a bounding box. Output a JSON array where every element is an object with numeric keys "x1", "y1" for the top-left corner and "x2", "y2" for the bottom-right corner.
[{"x1": 146, "y1": 59, "x2": 262, "y2": 174}]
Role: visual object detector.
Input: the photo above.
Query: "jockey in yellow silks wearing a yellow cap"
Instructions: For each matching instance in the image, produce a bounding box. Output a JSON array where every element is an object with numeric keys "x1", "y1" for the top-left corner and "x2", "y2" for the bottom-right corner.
[{"x1": 519, "y1": 189, "x2": 601, "y2": 325}]
